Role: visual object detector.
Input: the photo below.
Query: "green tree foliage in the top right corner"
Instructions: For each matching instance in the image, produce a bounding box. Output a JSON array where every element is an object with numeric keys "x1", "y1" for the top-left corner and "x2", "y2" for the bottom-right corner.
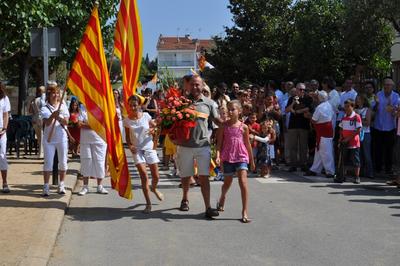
[{"x1": 343, "y1": 0, "x2": 400, "y2": 81}]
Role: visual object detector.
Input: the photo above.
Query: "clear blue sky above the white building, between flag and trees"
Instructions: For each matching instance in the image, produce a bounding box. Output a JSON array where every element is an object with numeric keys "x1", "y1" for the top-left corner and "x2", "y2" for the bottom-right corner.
[{"x1": 138, "y1": 0, "x2": 233, "y2": 59}]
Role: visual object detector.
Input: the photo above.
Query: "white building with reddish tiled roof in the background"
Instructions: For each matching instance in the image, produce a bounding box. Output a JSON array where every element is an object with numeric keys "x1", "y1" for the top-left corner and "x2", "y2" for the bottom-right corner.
[{"x1": 157, "y1": 35, "x2": 214, "y2": 78}]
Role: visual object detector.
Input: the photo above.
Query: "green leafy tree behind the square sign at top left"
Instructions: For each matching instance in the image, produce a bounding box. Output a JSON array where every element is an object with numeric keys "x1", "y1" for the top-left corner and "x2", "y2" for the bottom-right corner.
[{"x1": 0, "y1": 0, "x2": 119, "y2": 113}]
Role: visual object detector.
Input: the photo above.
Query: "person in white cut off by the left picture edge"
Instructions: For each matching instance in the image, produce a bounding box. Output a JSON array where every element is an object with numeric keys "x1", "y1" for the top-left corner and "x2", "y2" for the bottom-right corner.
[{"x1": 0, "y1": 83, "x2": 11, "y2": 193}]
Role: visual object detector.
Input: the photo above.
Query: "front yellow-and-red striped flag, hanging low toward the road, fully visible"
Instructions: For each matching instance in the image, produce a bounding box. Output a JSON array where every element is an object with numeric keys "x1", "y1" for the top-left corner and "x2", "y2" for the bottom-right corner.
[{"x1": 67, "y1": 6, "x2": 132, "y2": 199}]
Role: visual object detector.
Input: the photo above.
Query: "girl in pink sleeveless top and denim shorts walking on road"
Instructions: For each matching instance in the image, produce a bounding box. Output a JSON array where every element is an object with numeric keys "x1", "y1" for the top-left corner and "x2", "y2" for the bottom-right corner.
[{"x1": 216, "y1": 100, "x2": 255, "y2": 223}]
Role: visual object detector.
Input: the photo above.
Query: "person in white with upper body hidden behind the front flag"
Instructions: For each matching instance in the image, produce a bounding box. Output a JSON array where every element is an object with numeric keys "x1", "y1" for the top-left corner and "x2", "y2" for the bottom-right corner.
[{"x1": 78, "y1": 108, "x2": 108, "y2": 196}]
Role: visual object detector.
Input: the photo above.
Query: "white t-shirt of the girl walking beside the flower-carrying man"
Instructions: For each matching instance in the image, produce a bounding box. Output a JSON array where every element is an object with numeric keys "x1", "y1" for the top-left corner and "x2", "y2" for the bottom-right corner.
[{"x1": 124, "y1": 112, "x2": 153, "y2": 150}]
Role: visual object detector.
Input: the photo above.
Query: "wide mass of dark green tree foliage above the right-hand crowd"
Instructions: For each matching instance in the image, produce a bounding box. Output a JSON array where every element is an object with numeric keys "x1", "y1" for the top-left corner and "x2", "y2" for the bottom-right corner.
[{"x1": 207, "y1": 0, "x2": 400, "y2": 84}]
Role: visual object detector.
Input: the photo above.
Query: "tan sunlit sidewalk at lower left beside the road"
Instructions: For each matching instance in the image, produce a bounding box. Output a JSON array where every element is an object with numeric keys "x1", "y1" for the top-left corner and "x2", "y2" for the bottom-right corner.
[{"x1": 0, "y1": 155, "x2": 80, "y2": 265}]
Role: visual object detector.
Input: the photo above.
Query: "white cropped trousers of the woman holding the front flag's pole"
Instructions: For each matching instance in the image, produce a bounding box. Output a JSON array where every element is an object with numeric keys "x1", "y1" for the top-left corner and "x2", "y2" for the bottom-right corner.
[{"x1": 43, "y1": 142, "x2": 68, "y2": 172}]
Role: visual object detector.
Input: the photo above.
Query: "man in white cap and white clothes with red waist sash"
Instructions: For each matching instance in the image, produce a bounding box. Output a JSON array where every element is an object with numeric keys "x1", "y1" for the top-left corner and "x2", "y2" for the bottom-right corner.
[{"x1": 304, "y1": 91, "x2": 335, "y2": 178}]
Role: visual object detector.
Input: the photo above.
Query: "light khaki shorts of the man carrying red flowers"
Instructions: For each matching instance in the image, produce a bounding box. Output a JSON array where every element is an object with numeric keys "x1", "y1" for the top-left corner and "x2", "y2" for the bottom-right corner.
[{"x1": 176, "y1": 146, "x2": 211, "y2": 177}]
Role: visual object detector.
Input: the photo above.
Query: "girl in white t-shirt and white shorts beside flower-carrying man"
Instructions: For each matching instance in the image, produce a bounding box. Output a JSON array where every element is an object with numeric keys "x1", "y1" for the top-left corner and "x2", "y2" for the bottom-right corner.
[{"x1": 124, "y1": 95, "x2": 164, "y2": 213}]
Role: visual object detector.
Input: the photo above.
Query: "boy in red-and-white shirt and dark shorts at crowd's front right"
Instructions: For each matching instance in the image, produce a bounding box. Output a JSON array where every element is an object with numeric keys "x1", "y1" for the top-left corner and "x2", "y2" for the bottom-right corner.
[{"x1": 335, "y1": 99, "x2": 362, "y2": 184}]
